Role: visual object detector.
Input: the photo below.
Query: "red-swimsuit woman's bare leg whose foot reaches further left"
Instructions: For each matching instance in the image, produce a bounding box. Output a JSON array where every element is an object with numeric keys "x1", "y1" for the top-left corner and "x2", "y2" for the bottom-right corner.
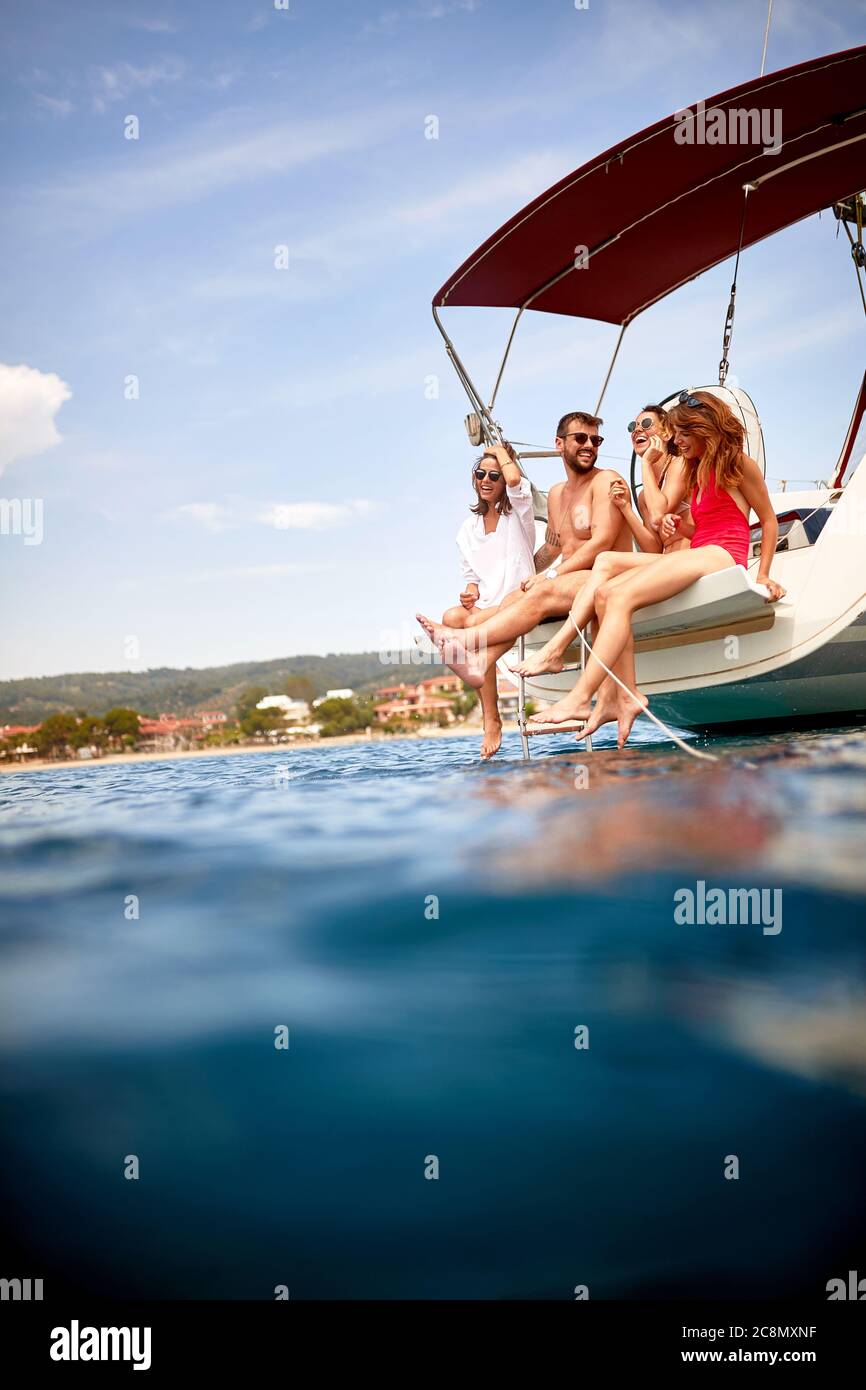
[{"x1": 534, "y1": 545, "x2": 734, "y2": 724}]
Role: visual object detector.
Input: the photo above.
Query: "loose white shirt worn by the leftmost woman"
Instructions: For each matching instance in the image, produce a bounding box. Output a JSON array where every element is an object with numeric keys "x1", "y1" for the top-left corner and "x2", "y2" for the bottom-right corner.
[{"x1": 457, "y1": 478, "x2": 535, "y2": 607}]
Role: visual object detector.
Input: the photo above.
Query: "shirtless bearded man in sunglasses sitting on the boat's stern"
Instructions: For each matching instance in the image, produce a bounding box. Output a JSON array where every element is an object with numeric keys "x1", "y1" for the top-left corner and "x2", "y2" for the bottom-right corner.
[{"x1": 417, "y1": 410, "x2": 631, "y2": 689}]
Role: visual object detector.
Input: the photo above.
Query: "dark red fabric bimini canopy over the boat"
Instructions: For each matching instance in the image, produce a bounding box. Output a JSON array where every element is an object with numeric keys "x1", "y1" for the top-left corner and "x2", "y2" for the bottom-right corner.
[{"x1": 434, "y1": 46, "x2": 866, "y2": 324}]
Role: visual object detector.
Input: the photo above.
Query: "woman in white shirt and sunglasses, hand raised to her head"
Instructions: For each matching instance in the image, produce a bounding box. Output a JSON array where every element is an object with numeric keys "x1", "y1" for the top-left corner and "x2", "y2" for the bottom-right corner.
[{"x1": 442, "y1": 445, "x2": 535, "y2": 759}]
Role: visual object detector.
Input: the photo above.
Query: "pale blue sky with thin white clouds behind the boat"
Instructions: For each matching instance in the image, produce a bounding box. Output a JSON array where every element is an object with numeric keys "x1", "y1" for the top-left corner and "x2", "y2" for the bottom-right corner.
[{"x1": 0, "y1": 0, "x2": 866, "y2": 677}]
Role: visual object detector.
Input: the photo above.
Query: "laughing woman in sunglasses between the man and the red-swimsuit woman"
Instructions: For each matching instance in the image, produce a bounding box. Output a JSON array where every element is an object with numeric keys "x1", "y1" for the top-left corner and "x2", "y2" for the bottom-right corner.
[{"x1": 512, "y1": 406, "x2": 688, "y2": 689}]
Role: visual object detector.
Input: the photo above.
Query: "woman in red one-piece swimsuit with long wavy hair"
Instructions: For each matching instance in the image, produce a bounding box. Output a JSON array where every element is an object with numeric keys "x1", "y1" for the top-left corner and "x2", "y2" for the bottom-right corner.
[{"x1": 532, "y1": 391, "x2": 785, "y2": 734}]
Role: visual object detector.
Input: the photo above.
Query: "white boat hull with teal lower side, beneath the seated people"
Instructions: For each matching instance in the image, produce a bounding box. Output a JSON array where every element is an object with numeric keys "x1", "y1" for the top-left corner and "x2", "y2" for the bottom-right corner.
[{"x1": 525, "y1": 468, "x2": 866, "y2": 728}]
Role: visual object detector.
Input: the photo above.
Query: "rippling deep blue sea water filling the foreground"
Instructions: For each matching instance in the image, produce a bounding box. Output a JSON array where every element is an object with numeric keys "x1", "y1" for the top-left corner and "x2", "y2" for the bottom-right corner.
[{"x1": 0, "y1": 730, "x2": 866, "y2": 1298}]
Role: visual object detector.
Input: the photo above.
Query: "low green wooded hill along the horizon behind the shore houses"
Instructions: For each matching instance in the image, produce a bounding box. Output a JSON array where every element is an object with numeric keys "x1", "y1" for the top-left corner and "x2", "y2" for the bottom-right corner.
[{"x1": 0, "y1": 652, "x2": 442, "y2": 724}]
